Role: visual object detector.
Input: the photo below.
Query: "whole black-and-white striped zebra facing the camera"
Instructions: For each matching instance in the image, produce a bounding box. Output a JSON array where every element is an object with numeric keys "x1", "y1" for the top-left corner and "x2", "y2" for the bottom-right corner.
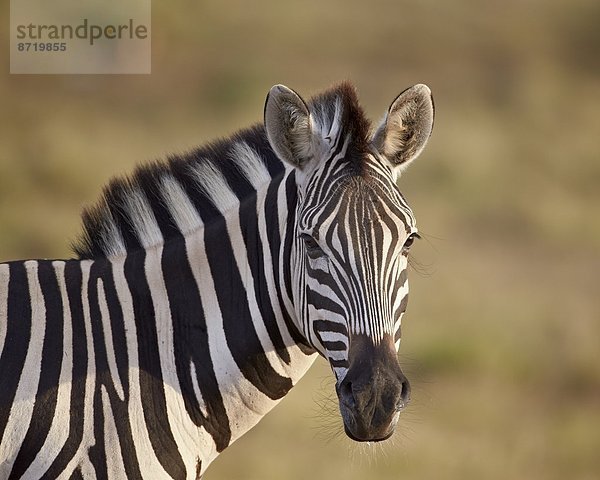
[{"x1": 0, "y1": 82, "x2": 434, "y2": 479}]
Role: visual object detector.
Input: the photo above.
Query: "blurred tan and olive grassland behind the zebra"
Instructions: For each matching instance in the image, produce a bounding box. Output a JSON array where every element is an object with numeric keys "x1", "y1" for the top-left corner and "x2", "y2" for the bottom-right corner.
[{"x1": 0, "y1": 0, "x2": 600, "y2": 480}]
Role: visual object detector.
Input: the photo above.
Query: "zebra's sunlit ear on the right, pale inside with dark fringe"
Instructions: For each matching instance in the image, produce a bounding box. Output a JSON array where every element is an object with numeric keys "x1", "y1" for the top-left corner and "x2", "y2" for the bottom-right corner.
[{"x1": 373, "y1": 84, "x2": 434, "y2": 170}]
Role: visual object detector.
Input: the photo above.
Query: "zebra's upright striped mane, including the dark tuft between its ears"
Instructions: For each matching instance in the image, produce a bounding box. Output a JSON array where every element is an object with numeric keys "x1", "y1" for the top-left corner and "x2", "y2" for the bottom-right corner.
[{"x1": 72, "y1": 82, "x2": 370, "y2": 259}]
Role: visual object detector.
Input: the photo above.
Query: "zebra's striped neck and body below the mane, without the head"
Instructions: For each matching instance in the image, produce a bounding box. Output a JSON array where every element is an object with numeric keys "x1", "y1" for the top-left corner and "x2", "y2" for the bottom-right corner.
[{"x1": 0, "y1": 167, "x2": 315, "y2": 478}]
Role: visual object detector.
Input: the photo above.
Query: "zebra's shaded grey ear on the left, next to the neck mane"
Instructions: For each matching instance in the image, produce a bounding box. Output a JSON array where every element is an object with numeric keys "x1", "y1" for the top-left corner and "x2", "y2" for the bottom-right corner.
[{"x1": 265, "y1": 85, "x2": 313, "y2": 170}]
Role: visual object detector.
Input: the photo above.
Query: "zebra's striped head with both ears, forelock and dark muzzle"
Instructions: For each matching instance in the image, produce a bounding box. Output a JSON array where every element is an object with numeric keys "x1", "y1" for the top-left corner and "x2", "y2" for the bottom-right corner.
[{"x1": 265, "y1": 84, "x2": 433, "y2": 441}]
